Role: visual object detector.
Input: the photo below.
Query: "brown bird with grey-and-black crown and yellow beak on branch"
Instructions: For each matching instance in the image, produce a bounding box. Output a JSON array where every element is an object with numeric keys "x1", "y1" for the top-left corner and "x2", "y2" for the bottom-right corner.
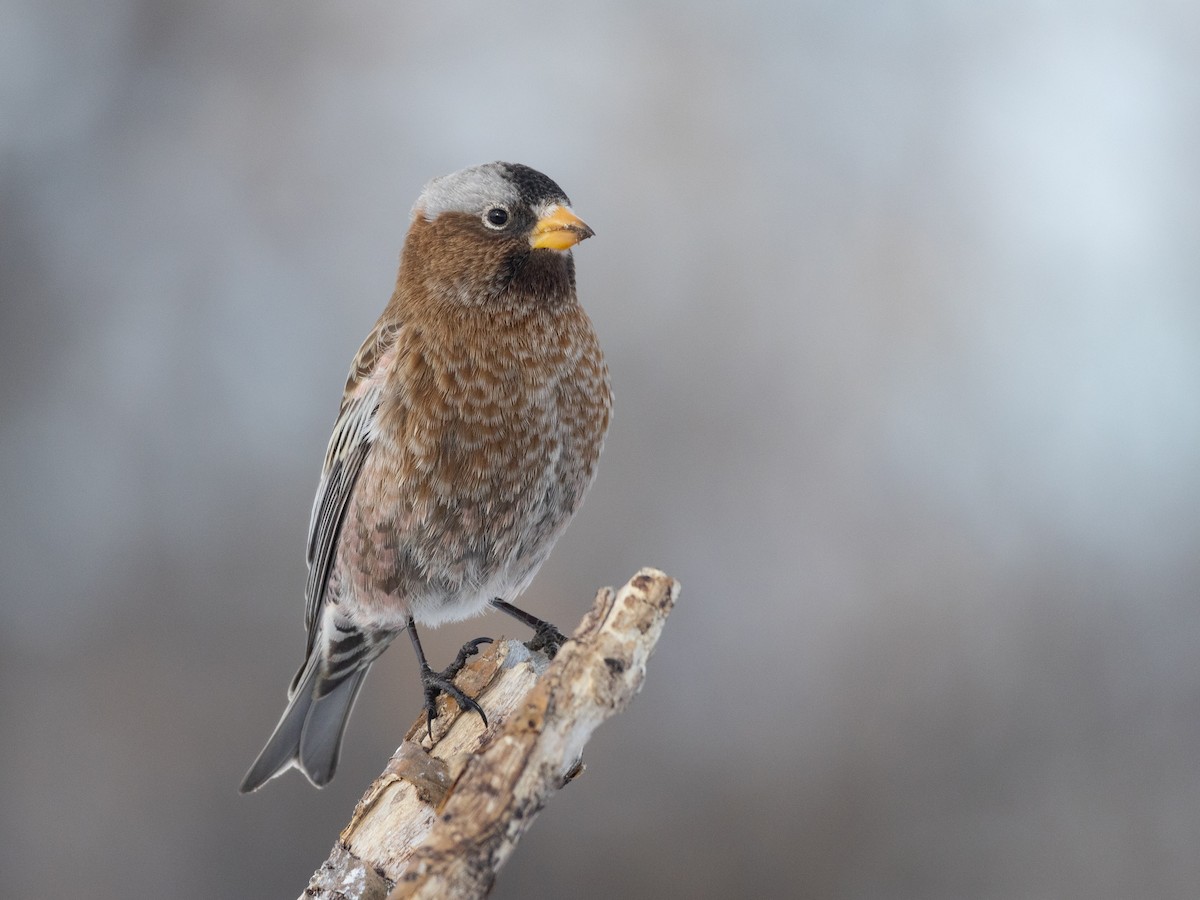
[{"x1": 240, "y1": 162, "x2": 612, "y2": 793}]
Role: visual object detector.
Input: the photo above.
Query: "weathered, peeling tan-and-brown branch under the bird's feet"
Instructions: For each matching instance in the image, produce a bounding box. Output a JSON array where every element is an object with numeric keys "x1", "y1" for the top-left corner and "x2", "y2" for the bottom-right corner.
[{"x1": 304, "y1": 569, "x2": 679, "y2": 900}]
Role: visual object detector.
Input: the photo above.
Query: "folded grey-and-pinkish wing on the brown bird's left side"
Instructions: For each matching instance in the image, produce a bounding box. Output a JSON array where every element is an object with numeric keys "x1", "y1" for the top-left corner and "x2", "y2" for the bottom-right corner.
[{"x1": 305, "y1": 319, "x2": 403, "y2": 652}]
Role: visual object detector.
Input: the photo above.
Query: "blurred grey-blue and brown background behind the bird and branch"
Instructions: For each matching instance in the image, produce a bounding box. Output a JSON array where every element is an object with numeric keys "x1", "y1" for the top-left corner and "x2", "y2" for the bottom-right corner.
[{"x1": 0, "y1": 0, "x2": 1200, "y2": 900}]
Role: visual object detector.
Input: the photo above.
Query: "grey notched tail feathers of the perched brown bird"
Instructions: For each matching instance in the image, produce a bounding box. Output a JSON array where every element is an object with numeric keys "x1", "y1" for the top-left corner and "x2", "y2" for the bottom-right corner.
[{"x1": 239, "y1": 648, "x2": 370, "y2": 793}]
